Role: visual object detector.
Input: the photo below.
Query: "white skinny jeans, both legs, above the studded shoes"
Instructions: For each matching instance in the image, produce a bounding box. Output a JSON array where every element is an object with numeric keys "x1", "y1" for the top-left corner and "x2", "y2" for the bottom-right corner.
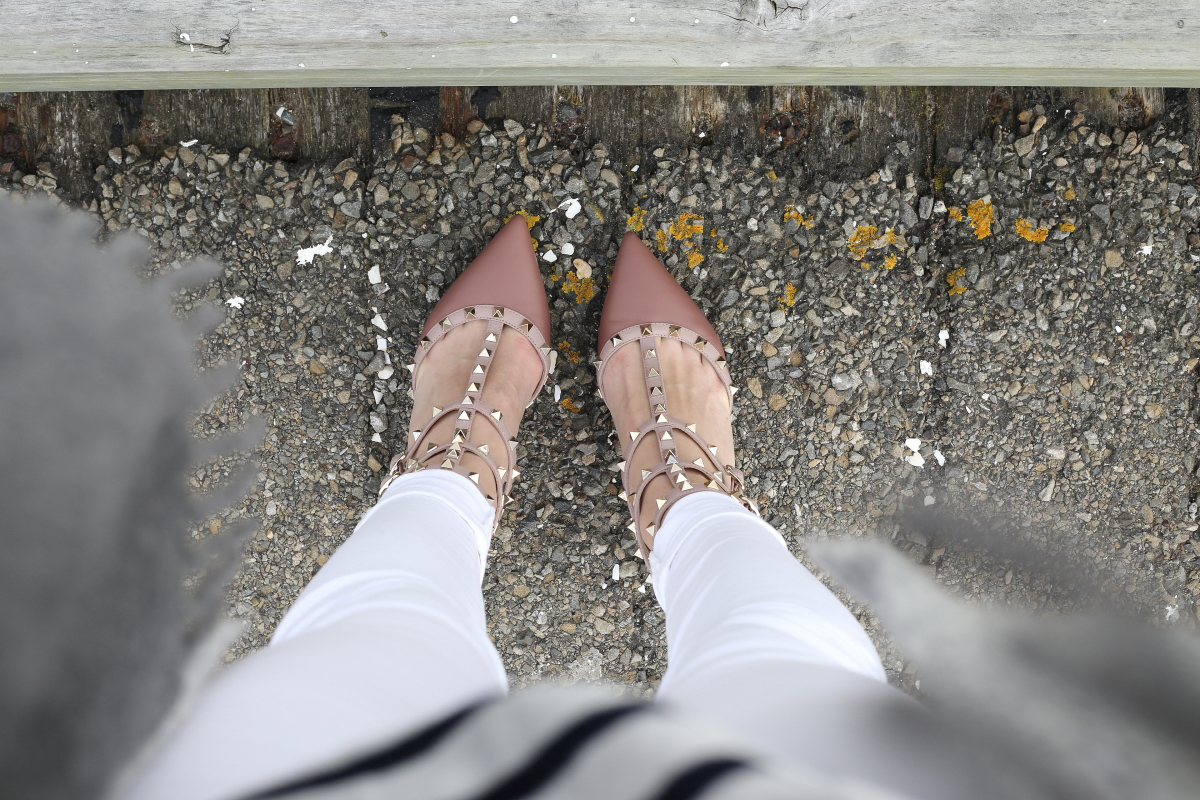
[{"x1": 120, "y1": 469, "x2": 895, "y2": 800}]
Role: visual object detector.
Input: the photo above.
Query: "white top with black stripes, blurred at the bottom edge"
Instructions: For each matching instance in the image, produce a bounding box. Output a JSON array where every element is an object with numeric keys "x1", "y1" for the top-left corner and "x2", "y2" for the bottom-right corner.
[{"x1": 246, "y1": 686, "x2": 898, "y2": 800}]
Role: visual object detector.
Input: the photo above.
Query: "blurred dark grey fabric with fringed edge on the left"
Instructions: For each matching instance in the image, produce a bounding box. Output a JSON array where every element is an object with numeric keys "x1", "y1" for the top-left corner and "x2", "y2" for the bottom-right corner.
[{"x1": 0, "y1": 197, "x2": 258, "y2": 799}]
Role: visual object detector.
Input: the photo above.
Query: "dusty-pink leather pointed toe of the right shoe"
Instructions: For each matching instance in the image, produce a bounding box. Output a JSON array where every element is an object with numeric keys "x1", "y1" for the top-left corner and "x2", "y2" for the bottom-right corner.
[{"x1": 596, "y1": 231, "x2": 724, "y2": 353}]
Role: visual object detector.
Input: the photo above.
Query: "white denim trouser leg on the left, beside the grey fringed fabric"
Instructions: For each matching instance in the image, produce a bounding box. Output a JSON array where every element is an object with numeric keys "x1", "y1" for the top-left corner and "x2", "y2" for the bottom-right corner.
[{"x1": 122, "y1": 469, "x2": 508, "y2": 800}]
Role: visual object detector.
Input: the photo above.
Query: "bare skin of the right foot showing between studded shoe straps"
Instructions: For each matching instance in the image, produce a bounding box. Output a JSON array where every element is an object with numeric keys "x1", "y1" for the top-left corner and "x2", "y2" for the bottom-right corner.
[{"x1": 604, "y1": 338, "x2": 734, "y2": 527}]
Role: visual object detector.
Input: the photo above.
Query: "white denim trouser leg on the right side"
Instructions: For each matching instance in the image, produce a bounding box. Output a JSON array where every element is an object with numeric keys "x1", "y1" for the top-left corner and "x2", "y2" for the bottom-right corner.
[{"x1": 650, "y1": 492, "x2": 968, "y2": 798}]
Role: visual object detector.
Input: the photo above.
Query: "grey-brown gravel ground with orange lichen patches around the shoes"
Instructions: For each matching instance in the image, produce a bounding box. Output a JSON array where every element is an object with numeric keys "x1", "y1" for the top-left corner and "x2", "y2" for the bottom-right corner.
[{"x1": 0, "y1": 95, "x2": 1200, "y2": 693}]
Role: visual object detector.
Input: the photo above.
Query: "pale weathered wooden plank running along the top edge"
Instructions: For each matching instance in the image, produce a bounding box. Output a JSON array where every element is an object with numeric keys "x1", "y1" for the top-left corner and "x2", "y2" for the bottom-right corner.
[{"x1": 0, "y1": 0, "x2": 1200, "y2": 91}]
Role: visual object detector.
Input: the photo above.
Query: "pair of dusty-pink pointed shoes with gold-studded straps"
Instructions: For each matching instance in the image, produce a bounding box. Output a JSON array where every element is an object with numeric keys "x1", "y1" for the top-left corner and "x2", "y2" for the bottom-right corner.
[{"x1": 379, "y1": 216, "x2": 757, "y2": 559}]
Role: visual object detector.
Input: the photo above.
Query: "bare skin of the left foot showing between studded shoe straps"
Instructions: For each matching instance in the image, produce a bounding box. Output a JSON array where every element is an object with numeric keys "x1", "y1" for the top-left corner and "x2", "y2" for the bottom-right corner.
[{"x1": 404, "y1": 320, "x2": 542, "y2": 497}]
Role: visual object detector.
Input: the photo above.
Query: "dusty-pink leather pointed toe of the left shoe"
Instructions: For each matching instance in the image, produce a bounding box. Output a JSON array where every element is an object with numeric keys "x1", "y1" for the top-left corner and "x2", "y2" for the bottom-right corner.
[{"x1": 421, "y1": 215, "x2": 550, "y2": 342}]
